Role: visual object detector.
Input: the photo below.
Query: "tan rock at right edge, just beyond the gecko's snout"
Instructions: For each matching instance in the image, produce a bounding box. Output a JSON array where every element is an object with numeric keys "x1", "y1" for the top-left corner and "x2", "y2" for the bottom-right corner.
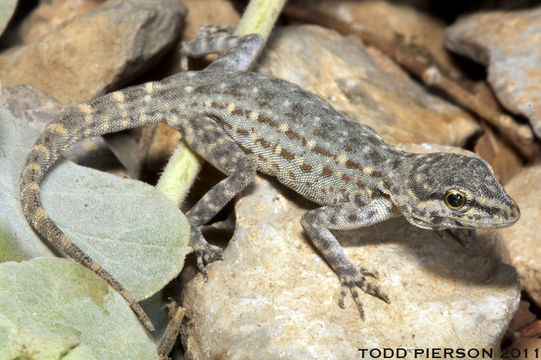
[{"x1": 501, "y1": 165, "x2": 541, "y2": 306}]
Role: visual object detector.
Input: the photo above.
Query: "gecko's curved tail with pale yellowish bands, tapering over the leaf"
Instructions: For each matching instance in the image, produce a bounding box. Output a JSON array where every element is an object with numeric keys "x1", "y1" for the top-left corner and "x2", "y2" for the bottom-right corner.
[{"x1": 19, "y1": 85, "x2": 166, "y2": 331}]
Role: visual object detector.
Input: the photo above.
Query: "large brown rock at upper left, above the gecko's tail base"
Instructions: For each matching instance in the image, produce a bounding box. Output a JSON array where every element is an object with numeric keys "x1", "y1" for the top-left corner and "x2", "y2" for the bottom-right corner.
[{"x1": 0, "y1": 0, "x2": 186, "y2": 103}]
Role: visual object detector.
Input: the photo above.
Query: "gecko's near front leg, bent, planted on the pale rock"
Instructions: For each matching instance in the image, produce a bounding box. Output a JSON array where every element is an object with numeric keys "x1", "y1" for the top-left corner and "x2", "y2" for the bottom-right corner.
[{"x1": 301, "y1": 197, "x2": 396, "y2": 320}]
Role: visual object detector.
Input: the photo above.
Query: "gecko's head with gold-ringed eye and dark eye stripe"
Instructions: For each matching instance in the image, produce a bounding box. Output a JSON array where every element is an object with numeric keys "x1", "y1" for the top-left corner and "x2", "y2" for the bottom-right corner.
[{"x1": 393, "y1": 153, "x2": 520, "y2": 229}]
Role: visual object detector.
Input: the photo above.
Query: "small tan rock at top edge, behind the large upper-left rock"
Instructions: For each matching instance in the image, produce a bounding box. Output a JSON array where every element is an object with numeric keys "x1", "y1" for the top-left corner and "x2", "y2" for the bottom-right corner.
[{"x1": 20, "y1": 0, "x2": 105, "y2": 43}]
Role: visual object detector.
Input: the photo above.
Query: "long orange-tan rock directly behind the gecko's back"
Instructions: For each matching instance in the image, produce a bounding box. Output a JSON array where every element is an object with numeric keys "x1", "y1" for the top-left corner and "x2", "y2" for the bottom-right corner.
[{"x1": 256, "y1": 26, "x2": 480, "y2": 146}]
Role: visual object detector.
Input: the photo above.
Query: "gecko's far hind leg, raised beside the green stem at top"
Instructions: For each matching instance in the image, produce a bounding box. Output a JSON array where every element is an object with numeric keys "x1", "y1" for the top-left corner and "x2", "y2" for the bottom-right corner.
[{"x1": 181, "y1": 24, "x2": 264, "y2": 71}]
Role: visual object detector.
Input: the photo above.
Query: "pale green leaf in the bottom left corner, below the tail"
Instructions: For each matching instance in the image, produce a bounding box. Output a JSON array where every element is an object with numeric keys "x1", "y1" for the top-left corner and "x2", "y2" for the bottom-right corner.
[{"x1": 0, "y1": 258, "x2": 158, "y2": 360}]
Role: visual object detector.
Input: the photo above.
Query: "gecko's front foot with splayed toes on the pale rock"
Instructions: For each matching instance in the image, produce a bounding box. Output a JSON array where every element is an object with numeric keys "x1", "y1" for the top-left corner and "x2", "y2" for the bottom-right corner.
[{"x1": 338, "y1": 265, "x2": 391, "y2": 320}]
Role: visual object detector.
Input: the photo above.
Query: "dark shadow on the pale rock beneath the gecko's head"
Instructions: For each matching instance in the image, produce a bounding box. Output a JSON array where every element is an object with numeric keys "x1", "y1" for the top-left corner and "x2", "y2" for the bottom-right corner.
[{"x1": 334, "y1": 218, "x2": 518, "y2": 287}]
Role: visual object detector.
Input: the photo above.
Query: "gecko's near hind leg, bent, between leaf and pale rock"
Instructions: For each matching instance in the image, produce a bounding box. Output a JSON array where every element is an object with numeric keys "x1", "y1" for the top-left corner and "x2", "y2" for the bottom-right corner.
[{"x1": 171, "y1": 115, "x2": 256, "y2": 279}]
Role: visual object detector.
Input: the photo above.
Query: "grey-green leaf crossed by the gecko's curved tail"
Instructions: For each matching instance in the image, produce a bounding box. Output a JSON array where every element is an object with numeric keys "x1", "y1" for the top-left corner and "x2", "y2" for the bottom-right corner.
[{"x1": 0, "y1": 102, "x2": 191, "y2": 300}]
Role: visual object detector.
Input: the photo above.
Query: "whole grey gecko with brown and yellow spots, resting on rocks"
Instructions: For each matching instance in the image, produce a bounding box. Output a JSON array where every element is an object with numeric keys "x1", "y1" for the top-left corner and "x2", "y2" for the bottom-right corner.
[{"x1": 20, "y1": 26, "x2": 520, "y2": 330}]
